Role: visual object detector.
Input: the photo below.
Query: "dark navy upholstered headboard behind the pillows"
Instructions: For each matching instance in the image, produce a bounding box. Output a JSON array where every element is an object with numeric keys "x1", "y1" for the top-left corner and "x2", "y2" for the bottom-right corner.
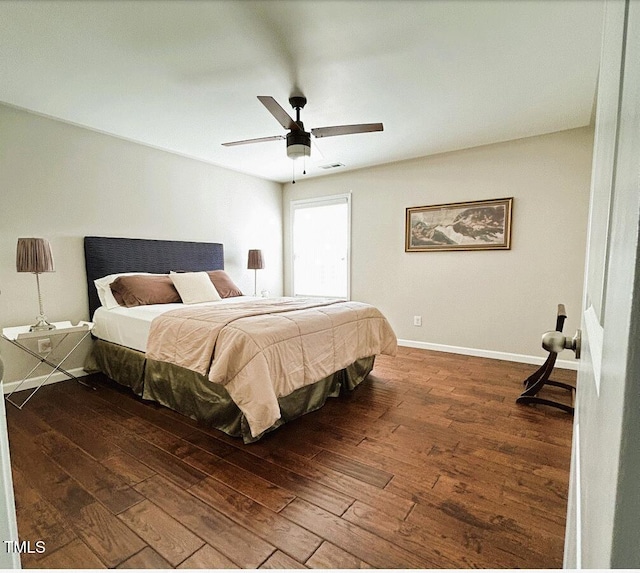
[{"x1": 84, "y1": 237, "x2": 224, "y2": 317}]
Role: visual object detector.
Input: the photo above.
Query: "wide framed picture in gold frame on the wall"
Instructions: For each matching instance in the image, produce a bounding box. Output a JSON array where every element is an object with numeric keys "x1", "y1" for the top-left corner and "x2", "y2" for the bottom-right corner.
[{"x1": 404, "y1": 197, "x2": 513, "y2": 252}]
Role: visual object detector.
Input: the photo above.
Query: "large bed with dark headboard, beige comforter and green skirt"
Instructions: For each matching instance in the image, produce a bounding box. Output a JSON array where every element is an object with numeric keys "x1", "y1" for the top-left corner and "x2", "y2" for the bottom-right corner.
[{"x1": 84, "y1": 237, "x2": 396, "y2": 443}]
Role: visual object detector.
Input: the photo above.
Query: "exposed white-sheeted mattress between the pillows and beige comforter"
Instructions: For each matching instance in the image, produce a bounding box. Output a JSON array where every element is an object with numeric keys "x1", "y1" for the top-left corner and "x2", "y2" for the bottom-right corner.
[{"x1": 92, "y1": 296, "x2": 257, "y2": 352}]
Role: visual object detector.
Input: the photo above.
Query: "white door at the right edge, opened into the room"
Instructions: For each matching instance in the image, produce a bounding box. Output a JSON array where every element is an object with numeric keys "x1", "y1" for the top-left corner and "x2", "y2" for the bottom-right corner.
[{"x1": 564, "y1": 0, "x2": 640, "y2": 568}]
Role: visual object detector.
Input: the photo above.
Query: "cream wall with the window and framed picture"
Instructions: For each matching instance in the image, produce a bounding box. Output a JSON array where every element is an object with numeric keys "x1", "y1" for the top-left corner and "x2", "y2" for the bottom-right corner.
[{"x1": 283, "y1": 128, "x2": 593, "y2": 362}]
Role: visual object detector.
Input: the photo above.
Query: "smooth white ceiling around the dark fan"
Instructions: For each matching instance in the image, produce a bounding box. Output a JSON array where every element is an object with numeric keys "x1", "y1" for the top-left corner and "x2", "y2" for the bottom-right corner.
[{"x1": 0, "y1": 0, "x2": 603, "y2": 182}]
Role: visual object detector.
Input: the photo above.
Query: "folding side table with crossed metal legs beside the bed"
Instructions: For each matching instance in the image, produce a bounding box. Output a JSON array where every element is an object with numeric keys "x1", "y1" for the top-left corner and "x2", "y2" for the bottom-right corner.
[{"x1": 2, "y1": 320, "x2": 95, "y2": 410}]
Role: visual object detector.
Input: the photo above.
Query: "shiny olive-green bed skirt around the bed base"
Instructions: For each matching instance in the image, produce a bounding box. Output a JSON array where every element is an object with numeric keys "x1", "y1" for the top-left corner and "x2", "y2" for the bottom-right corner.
[{"x1": 85, "y1": 340, "x2": 375, "y2": 443}]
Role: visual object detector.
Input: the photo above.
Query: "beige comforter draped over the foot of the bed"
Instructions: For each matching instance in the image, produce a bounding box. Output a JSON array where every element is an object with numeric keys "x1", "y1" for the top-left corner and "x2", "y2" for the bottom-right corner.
[{"x1": 147, "y1": 298, "x2": 396, "y2": 437}]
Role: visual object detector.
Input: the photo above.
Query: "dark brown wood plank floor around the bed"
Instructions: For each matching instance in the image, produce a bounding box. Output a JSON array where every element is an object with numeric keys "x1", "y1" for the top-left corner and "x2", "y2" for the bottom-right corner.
[{"x1": 7, "y1": 348, "x2": 575, "y2": 569}]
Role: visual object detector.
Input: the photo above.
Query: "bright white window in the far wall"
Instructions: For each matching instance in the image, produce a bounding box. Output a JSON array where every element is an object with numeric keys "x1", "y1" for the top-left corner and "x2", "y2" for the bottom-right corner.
[{"x1": 291, "y1": 194, "x2": 351, "y2": 299}]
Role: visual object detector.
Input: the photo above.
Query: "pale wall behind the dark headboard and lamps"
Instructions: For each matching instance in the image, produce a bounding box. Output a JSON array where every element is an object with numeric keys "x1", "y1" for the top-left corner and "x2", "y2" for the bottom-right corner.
[{"x1": 0, "y1": 105, "x2": 283, "y2": 382}]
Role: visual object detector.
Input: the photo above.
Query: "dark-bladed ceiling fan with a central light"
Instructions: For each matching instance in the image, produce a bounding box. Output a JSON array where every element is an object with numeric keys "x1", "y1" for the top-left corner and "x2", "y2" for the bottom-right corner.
[{"x1": 222, "y1": 95, "x2": 383, "y2": 159}]
